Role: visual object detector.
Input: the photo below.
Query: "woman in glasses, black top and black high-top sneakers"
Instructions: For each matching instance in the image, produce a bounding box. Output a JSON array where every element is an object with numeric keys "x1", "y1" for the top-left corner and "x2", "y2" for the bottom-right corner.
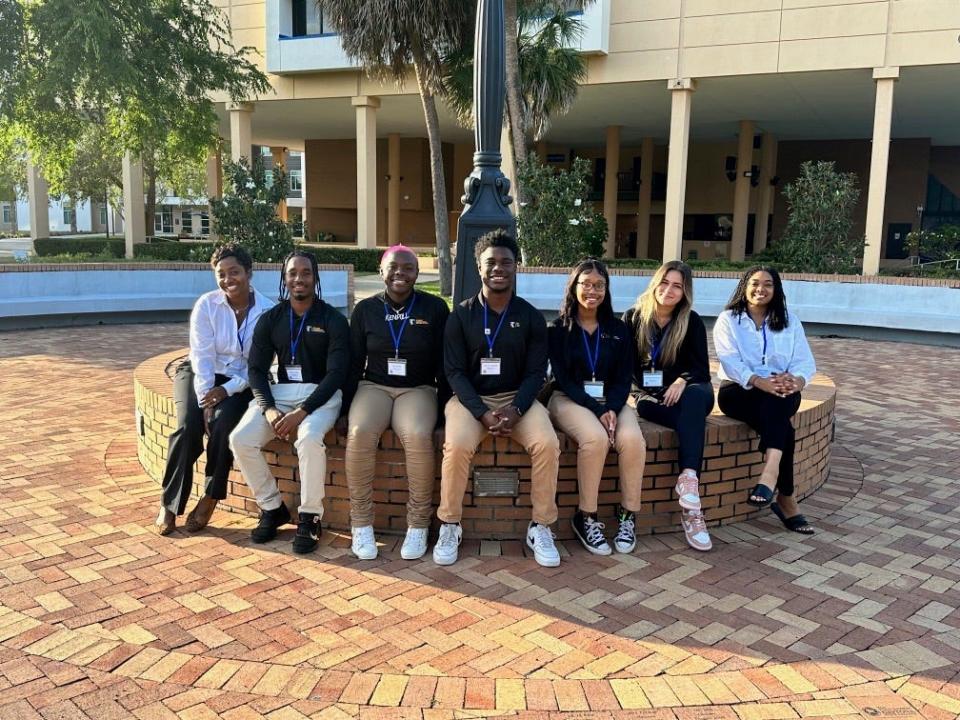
[{"x1": 548, "y1": 260, "x2": 647, "y2": 555}]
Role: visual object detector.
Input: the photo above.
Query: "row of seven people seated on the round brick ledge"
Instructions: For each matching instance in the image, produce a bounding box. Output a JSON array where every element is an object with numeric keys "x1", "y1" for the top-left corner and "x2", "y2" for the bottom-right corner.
[{"x1": 156, "y1": 230, "x2": 815, "y2": 567}]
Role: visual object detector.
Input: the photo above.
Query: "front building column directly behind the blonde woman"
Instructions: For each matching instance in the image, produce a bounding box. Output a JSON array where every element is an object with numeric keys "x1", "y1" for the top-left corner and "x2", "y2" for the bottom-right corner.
[{"x1": 663, "y1": 78, "x2": 696, "y2": 262}]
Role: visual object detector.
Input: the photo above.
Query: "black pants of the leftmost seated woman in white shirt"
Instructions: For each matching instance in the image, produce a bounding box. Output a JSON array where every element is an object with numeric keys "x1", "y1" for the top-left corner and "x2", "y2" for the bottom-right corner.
[{"x1": 163, "y1": 362, "x2": 253, "y2": 515}]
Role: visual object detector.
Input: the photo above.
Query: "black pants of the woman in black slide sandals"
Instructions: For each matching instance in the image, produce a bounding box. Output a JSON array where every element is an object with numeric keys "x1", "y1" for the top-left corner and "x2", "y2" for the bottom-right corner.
[{"x1": 717, "y1": 383, "x2": 800, "y2": 496}]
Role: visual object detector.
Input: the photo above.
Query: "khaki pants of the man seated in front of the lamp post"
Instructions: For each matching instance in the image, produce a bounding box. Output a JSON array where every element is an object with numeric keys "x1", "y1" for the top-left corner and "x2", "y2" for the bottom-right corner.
[{"x1": 437, "y1": 393, "x2": 560, "y2": 525}]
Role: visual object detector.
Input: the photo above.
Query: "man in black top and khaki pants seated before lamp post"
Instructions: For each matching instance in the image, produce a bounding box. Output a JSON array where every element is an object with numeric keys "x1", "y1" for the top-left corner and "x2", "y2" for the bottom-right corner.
[{"x1": 433, "y1": 229, "x2": 560, "y2": 567}]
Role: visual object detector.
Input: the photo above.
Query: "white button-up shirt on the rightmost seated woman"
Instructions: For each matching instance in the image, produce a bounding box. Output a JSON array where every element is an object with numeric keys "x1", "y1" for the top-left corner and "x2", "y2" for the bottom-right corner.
[{"x1": 713, "y1": 310, "x2": 817, "y2": 389}]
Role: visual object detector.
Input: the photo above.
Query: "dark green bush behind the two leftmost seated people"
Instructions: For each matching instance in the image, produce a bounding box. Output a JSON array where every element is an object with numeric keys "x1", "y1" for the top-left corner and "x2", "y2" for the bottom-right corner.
[{"x1": 210, "y1": 158, "x2": 293, "y2": 262}]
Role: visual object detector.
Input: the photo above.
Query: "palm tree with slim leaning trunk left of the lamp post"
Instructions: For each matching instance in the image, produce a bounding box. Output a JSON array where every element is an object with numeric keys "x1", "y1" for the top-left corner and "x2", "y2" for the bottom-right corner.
[{"x1": 317, "y1": 0, "x2": 474, "y2": 296}]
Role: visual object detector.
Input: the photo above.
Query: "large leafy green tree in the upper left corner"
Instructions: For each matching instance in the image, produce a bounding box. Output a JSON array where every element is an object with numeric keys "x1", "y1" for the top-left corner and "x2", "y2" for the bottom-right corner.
[{"x1": 0, "y1": 0, "x2": 270, "y2": 239}]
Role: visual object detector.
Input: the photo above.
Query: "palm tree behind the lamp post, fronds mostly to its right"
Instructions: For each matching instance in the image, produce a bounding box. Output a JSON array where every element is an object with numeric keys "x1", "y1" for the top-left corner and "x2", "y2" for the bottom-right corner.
[{"x1": 444, "y1": 0, "x2": 592, "y2": 200}]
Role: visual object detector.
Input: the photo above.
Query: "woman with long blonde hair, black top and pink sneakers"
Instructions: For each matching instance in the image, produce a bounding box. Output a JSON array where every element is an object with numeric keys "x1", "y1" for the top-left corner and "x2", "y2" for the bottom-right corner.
[{"x1": 623, "y1": 260, "x2": 713, "y2": 550}]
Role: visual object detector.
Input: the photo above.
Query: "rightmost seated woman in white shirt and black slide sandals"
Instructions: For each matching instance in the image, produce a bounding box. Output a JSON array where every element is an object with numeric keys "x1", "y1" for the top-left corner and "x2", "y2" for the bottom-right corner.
[{"x1": 713, "y1": 266, "x2": 817, "y2": 534}]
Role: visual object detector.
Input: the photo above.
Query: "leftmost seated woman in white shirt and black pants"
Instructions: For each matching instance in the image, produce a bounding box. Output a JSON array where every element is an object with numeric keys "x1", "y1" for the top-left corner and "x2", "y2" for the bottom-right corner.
[{"x1": 157, "y1": 245, "x2": 273, "y2": 535}]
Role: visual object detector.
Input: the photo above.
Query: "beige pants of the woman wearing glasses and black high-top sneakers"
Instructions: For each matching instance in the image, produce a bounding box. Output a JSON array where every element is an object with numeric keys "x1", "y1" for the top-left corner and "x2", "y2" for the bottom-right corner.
[{"x1": 549, "y1": 391, "x2": 647, "y2": 512}]
